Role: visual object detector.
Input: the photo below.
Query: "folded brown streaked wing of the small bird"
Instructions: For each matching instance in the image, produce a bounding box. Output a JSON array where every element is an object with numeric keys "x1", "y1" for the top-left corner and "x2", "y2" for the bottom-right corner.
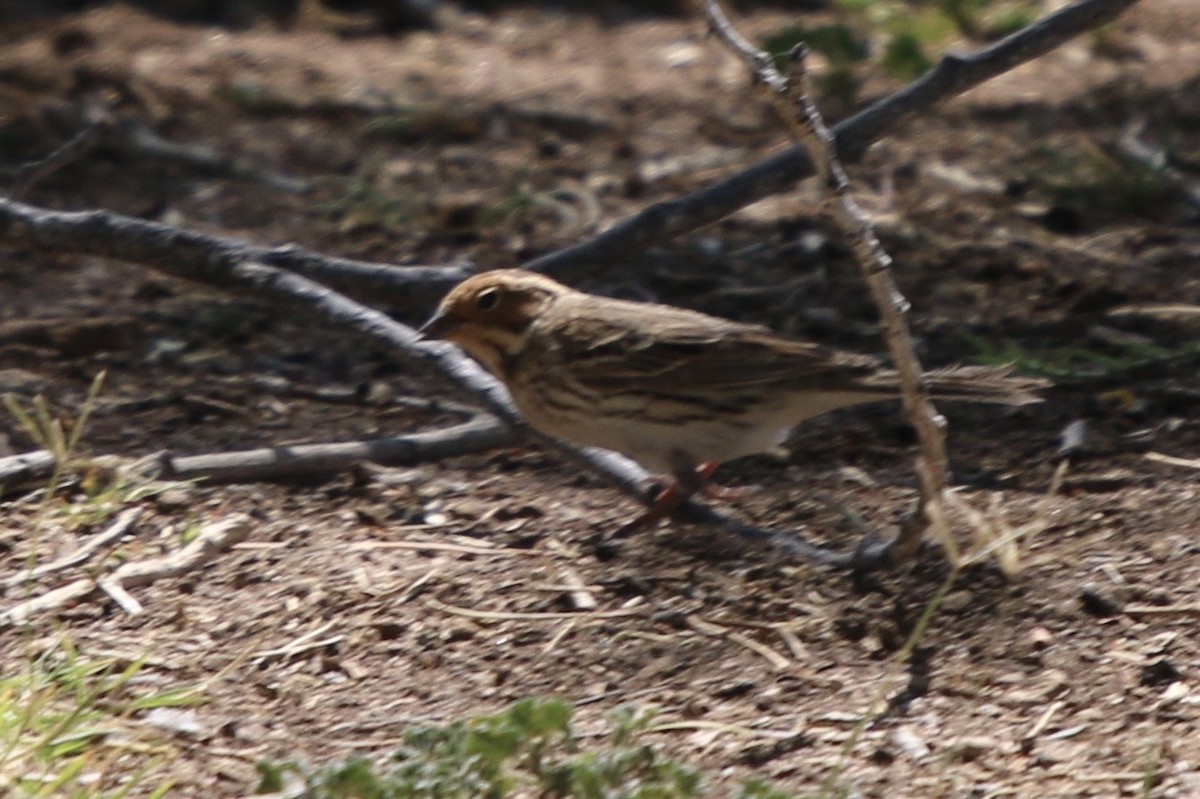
[{"x1": 556, "y1": 306, "x2": 880, "y2": 394}]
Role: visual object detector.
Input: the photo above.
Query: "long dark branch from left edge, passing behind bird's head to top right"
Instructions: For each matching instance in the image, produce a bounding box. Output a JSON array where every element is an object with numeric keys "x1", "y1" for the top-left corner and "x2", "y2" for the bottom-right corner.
[{"x1": 0, "y1": 0, "x2": 1138, "y2": 306}]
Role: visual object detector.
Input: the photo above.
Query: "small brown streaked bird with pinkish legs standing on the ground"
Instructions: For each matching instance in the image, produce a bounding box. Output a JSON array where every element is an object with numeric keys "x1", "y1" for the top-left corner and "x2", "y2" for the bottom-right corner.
[{"x1": 420, "y1": 269, "x2": 1046, "y2": 527}]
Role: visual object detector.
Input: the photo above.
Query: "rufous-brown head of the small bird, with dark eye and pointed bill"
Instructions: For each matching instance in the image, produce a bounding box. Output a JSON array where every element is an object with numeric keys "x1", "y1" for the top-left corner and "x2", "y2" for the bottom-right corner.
[{"x1": 419, "y1": 269, "x2": 571, "y2": 376}]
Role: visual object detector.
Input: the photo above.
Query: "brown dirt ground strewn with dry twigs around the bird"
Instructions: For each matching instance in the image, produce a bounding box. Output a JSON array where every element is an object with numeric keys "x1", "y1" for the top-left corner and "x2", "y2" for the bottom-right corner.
[{"x1": 0, "y1": 0, "x2": 1200, "y2": 797}]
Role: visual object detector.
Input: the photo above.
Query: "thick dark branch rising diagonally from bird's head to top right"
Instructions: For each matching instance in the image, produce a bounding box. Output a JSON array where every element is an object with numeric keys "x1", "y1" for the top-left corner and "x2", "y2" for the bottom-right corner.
[{"x1": 526, "y1": 0, "x2": 1138, "y2": 281}]
